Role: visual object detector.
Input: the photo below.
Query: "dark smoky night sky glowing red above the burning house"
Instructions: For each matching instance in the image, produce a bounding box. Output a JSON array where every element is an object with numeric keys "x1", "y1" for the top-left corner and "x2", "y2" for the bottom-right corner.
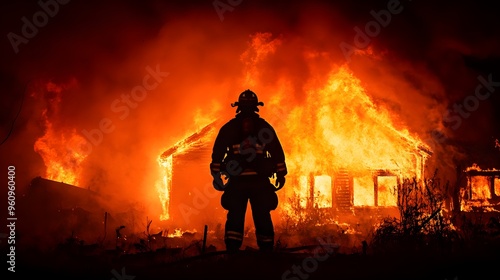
[{"x1": 0, "y1": 0, "x2": 500, "y2": 195}]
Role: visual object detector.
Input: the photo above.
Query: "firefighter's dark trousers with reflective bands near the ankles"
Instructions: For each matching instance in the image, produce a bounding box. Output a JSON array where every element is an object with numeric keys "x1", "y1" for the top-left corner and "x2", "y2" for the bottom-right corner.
[{"x1": 221, "y1": 175, "x2": 278, "y2": 251}]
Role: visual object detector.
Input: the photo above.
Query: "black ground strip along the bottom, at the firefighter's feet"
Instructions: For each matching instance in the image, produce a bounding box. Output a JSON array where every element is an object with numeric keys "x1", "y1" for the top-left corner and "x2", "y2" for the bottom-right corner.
[{"x1": 7, "y1": 241, "x2": 500, "y2": 280}]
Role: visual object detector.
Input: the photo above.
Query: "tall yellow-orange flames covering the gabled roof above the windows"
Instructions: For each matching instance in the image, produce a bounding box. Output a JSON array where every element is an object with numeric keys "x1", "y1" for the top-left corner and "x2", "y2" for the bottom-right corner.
[{"x1": 286, "y1": 66, "x2": 430, "y2": 175}]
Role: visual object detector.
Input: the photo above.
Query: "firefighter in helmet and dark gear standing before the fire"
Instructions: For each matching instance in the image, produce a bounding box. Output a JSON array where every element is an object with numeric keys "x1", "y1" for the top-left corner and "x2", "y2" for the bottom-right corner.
[{"x1": 210, "y1": 89, "x2": 287, "y2": 252}]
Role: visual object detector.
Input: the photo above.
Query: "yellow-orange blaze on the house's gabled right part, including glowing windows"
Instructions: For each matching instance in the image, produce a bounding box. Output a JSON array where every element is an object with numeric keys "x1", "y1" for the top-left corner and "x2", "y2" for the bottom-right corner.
[{"x1": 280, "y1": 65, "x2": 430, "y2": 212}]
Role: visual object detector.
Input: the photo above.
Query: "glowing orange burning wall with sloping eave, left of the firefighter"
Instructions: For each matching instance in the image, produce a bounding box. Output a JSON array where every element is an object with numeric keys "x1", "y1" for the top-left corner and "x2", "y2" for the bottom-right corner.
[{"x1": 156, "y1": 121, "x2": 222, "y2": 224}]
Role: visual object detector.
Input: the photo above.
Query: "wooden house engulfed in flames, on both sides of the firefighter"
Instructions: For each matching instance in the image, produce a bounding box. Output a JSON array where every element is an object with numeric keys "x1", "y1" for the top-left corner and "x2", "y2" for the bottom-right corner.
[{"x1": 159, "y1": 65, "x2": 432, "y2": 230}]
